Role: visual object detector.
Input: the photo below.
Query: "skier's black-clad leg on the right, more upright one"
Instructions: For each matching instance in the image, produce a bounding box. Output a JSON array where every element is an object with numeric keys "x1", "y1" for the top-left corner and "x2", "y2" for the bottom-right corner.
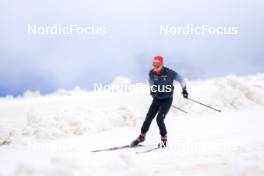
[{"x1": 157, "y1": 98, "x2": 173, "y2": 137}]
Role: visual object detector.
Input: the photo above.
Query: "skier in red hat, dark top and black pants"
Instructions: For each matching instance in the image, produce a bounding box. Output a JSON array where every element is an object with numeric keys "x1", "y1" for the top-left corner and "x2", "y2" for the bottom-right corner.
[{"x1": 130, "y1": 56, "x2": 188, "y2": 148}]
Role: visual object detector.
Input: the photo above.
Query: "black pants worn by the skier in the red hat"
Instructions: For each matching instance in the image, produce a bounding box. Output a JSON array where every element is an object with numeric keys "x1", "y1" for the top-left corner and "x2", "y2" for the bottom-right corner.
[{"x1": 141, "y1": 98, "x2": 172, "y2": 136}]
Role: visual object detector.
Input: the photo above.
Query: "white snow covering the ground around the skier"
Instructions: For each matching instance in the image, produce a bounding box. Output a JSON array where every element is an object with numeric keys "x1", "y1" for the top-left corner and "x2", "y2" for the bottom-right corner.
[{"x1": 0, "y1": 74, "x2": 264, "y2": 176}]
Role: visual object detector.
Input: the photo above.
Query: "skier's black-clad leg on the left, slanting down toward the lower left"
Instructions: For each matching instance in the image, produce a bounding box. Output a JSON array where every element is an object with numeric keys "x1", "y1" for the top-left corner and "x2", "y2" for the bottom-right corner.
[{"x1": 141, "y1": 99, "x2": 160, "y2": 134}]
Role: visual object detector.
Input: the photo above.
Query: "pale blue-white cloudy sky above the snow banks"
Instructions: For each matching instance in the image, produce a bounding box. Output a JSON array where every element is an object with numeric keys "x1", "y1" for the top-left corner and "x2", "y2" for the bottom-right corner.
[{"x1": 0, "y1": 0, "x2": 264, "y2": 96}]
